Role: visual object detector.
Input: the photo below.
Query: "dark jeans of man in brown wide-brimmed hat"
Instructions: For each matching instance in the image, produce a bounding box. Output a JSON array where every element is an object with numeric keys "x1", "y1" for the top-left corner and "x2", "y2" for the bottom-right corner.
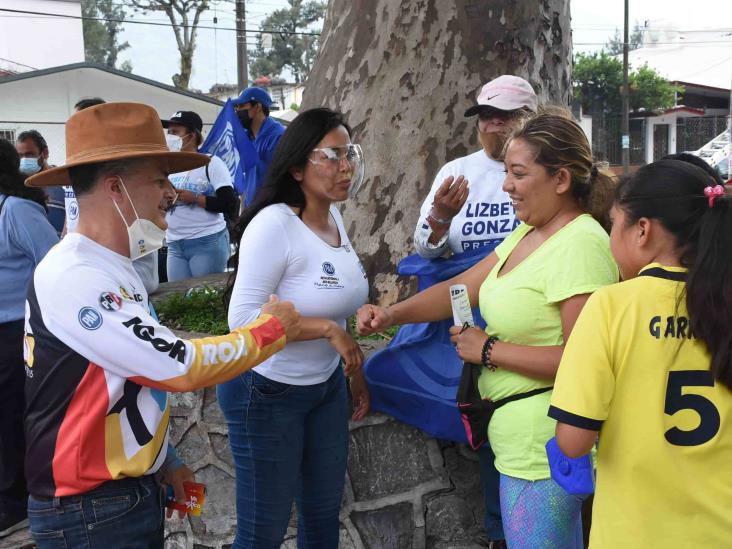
[{"x1": 28, "y1": 475, "x2": 164, "y2": 549}]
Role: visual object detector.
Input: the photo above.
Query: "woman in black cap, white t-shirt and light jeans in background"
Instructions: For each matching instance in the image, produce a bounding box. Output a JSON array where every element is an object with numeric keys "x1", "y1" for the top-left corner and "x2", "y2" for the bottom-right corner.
[{"x1": 162, "y1": 111, "x2": 239, "y2": 282}]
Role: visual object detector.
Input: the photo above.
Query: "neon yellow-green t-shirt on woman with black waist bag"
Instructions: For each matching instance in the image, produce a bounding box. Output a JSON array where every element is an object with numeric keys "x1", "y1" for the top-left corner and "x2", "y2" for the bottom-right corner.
[{"x1": 478, "y1": 214, "x2": 618, "y2": 480}]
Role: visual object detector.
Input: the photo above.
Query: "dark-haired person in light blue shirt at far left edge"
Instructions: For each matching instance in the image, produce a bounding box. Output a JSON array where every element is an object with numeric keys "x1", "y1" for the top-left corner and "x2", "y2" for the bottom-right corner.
[{"x1": 0, "y1": 139, "x2": 58, "y2": 538}]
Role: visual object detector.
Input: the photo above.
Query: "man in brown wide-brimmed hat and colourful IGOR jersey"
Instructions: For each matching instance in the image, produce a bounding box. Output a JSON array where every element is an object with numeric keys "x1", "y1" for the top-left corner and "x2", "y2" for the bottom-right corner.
[{"x1": 20, "y1": 103, "x2": 300, "y2": 549}]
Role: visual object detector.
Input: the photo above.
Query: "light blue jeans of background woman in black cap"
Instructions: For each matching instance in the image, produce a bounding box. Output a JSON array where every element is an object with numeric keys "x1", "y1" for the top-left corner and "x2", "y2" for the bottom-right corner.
[{"x1": 168, "y1": 229, "x2": 230, "y2": 282}]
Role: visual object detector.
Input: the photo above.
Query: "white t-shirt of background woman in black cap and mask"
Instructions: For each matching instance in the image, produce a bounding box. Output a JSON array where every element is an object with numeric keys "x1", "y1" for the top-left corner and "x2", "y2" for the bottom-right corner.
[{"x1": 165, "y1": 156, "x2": 233, "y2": 242}]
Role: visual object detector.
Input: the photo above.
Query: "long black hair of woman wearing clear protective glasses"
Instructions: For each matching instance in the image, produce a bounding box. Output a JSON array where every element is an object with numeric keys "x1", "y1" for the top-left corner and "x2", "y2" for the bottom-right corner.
[{"x1": 224, "y1": 107, "x2": 351, "y2": 306}]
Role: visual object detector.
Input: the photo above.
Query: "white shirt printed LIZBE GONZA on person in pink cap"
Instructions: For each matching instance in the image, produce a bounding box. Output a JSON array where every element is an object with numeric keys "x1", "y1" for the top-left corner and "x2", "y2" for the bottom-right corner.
[{"x1": 414, "y1": 149, "x2": 519, "y2": 258}]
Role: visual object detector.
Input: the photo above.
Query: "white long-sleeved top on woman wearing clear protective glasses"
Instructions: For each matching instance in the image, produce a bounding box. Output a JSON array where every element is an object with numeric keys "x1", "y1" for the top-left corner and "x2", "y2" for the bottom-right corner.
[{"x1": 229, "y1": 204, "x2": 368, "y2": 385}]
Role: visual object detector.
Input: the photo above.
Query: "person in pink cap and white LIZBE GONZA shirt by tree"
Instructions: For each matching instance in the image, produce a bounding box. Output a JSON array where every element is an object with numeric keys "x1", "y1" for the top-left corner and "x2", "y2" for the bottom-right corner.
[{"x1": 414, "y1": 75, "x2": 537, "y2": 548}]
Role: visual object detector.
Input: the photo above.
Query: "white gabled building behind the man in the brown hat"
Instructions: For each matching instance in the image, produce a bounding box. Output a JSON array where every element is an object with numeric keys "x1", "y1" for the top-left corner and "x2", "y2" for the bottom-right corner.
[{"x1": 0, "y1": 63, "x2": 223, "y2": 164}]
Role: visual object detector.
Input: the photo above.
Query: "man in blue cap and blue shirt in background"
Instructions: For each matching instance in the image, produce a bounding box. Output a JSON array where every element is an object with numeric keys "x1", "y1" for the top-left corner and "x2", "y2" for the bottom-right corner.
[{"x1": 232, "y1": 87, "x2": 285, "y2": 205}]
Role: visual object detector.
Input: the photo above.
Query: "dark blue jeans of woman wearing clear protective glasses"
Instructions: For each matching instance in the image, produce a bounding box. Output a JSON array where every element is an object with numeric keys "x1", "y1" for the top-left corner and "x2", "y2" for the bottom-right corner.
[{"x1": 217, "y1": 368, "x2": 348, "y2": 549}]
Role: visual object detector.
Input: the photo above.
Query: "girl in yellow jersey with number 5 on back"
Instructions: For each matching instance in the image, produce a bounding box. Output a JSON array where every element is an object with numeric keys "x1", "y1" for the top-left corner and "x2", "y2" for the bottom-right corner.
[{"x1": 549, "y1": 160, "x2": 732, "y2": 549}]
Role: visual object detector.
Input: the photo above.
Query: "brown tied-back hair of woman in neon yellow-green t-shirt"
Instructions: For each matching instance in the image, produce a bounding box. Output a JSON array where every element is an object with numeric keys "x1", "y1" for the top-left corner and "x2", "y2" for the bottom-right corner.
[{"x1": 511, "y1": 109, "x2": 615, "y2": 232}]
